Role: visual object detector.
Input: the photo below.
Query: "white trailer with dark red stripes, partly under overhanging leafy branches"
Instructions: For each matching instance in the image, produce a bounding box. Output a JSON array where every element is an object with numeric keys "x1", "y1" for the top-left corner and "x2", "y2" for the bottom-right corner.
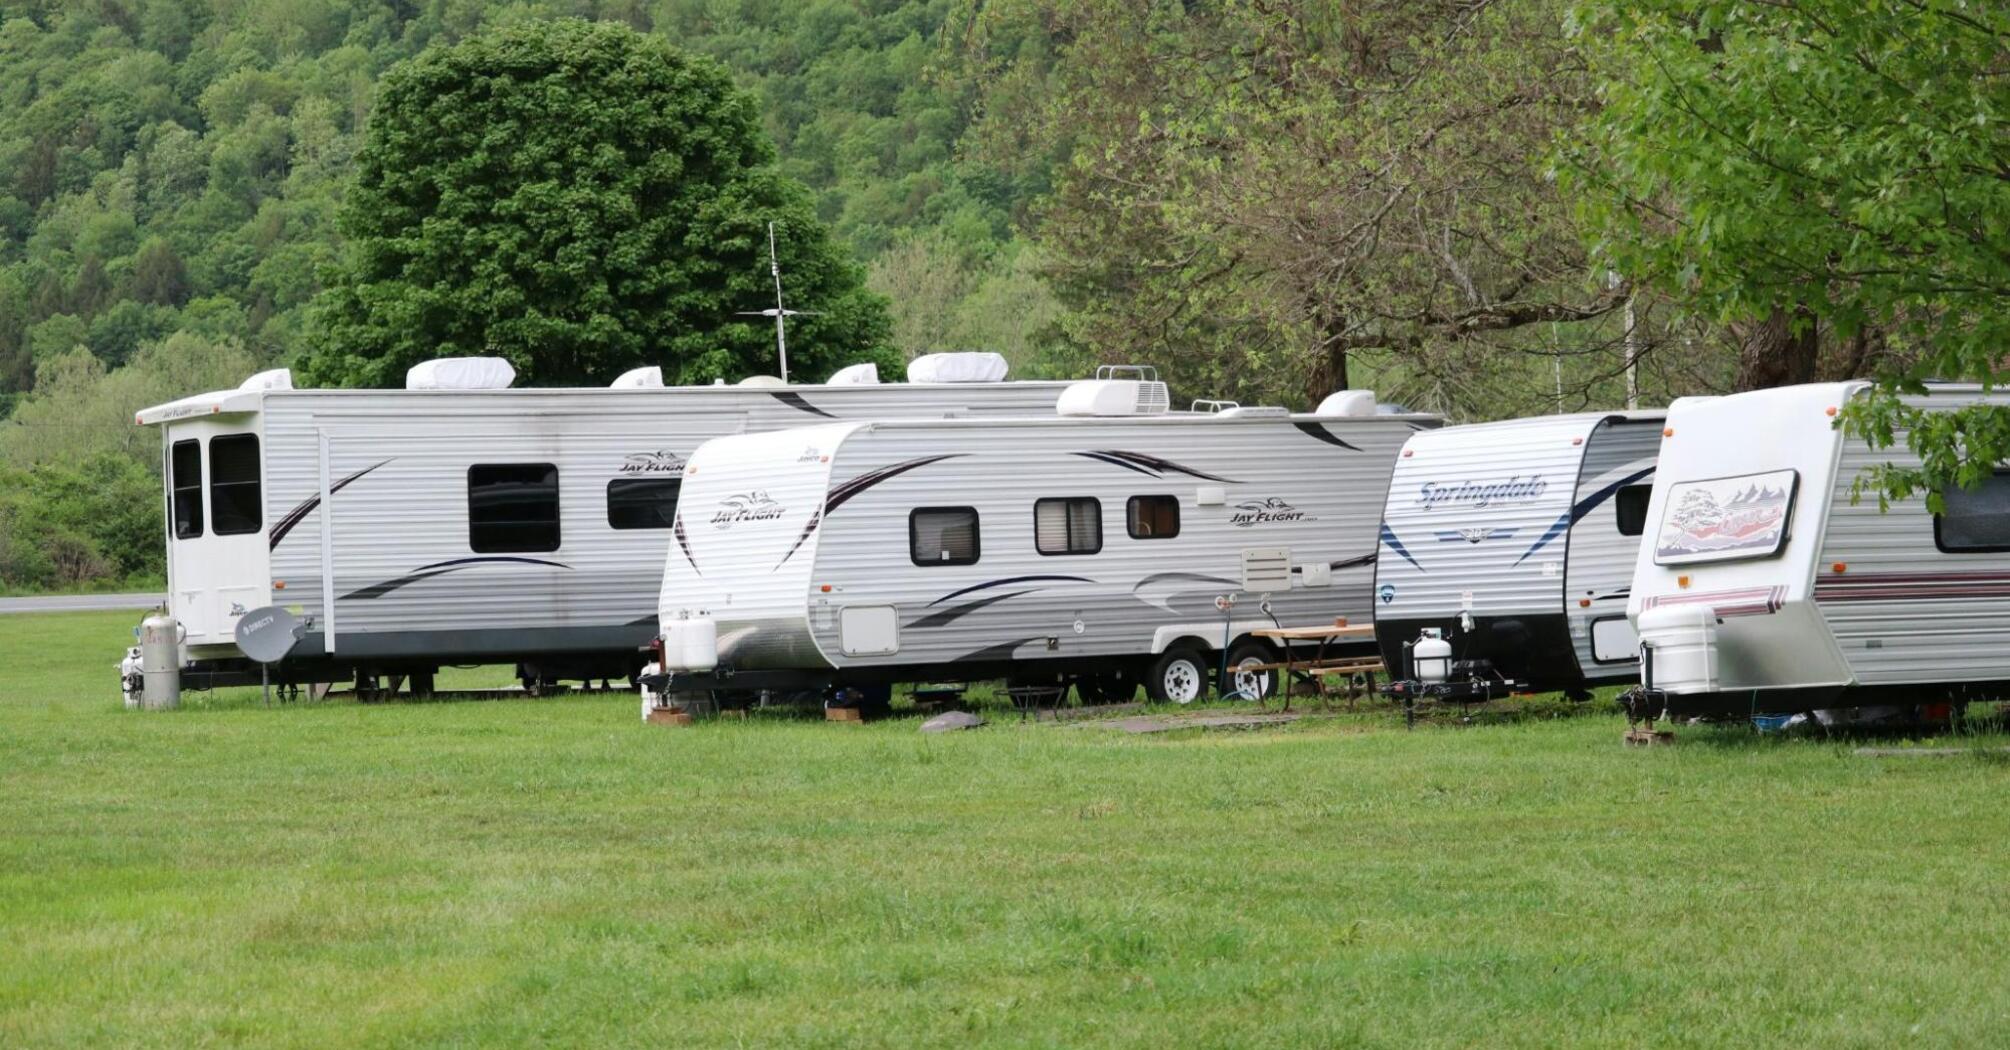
[{"x1": 1628, "y1": 382, "x2": 2010, "y2": 716}]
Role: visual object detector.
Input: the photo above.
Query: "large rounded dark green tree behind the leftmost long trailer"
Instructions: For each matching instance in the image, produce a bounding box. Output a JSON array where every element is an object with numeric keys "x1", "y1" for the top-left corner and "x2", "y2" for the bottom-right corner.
[{"x1": 310, "y1": 20, "x2": 890, "y2": 386}]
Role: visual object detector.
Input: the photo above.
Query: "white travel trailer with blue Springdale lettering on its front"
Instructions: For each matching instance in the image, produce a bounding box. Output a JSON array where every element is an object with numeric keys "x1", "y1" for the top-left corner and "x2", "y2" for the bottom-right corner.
[{"x1": 1375, "y1": 410, "x2": 1662, "y2": 702}]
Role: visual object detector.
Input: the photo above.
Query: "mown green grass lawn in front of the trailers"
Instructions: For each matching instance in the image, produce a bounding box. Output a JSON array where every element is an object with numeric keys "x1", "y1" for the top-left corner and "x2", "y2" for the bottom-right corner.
[{"x1": 0, "y1": 614, "x2": 2010, "y2": 1048}]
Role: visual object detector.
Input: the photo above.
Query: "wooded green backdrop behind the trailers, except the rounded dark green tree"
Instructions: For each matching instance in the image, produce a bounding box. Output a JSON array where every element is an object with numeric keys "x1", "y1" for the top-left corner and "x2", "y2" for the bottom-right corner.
[{"x1": 0, "y1": 0, "x2": 2010, "y2": 585}]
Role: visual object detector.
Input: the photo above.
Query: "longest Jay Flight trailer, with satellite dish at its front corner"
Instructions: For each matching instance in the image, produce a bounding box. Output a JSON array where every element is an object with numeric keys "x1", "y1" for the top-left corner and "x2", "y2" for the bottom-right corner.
[{"x1": 137, "y1": 354, "x2": 1067, "y2": 690}]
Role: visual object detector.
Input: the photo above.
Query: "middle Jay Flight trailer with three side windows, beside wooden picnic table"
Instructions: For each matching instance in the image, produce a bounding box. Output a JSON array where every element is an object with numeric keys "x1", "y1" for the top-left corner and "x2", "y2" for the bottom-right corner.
[{"x1": 643, "y1": 380, "x2": 1437, "y2": 706}]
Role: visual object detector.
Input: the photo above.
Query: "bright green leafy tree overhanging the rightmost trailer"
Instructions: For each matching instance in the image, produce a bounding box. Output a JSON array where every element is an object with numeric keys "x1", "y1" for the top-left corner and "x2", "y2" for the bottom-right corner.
[{"x1": 1572, "y1": 0, "x2": 2010, "y2": 501}]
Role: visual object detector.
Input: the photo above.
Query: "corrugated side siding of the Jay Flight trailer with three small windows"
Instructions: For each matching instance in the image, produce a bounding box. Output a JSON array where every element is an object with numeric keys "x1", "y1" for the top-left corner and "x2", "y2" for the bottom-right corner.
[{"x1": 787, "y1": 416, "x2": 1433, "y2": 666}]
